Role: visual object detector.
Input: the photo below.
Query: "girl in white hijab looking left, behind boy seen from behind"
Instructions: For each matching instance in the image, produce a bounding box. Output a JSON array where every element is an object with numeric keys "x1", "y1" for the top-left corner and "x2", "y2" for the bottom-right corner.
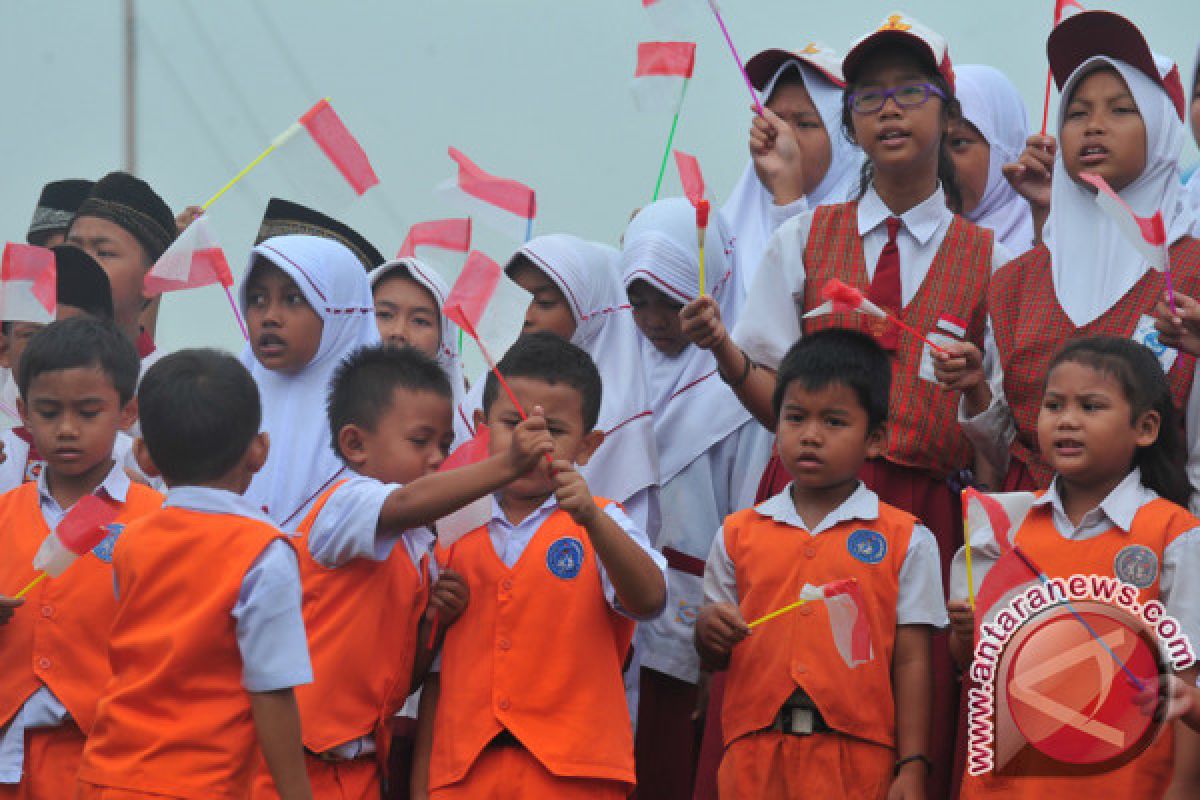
[{"x1": 241, "y1": 235, "x2": 379, "y2": 531}]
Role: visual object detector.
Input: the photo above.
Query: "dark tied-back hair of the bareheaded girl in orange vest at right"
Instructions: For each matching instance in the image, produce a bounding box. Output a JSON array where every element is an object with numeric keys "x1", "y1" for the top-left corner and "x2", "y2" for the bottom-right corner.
[{"x1": 1046, "y1": 336, "x2": 1194, "y2": 507}]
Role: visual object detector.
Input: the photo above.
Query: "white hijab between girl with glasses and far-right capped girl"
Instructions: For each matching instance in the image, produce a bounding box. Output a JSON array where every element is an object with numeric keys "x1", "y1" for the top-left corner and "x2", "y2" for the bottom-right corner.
[{"x1": 954, "y1": 64, "x2": 1033, "y2": 255}]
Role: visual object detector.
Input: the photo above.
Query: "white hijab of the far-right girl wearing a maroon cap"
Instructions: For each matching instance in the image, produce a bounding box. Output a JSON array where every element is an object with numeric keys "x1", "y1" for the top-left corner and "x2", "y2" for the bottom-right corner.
[{"x1": 1044, "y1": 56, "x2": 1196, "y2": 326}]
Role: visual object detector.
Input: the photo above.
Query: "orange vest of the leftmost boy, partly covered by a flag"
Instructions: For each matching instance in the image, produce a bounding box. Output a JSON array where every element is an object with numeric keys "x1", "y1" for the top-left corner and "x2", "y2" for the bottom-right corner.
[{"x1": 0, "y1": 482, "x2": 162, "y2": 733}]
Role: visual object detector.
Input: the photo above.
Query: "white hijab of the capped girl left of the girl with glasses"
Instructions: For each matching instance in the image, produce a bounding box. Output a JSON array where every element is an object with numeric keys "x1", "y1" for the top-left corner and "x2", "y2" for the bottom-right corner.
[{"x1": 719, "y1": 59, "x2": 863, "y2": 294}]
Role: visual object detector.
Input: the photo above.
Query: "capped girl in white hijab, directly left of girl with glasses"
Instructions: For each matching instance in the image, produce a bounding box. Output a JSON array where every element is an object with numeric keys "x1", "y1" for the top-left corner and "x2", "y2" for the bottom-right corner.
[{"x1": 720, "y1": 43, "x2": 863, "y2": 293}]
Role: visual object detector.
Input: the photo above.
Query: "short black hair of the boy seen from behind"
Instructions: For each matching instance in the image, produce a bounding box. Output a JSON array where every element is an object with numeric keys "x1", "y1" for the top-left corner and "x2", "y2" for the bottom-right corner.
[{"x1": 138, "y1": 349, "x2": 263, "y2": 486}]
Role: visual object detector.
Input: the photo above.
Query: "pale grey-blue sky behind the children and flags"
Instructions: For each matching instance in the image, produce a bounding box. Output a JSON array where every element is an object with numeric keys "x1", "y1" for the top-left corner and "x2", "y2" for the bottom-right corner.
[{"x1": 0, "y1": 0, "x2": 1200, "y2": 359}]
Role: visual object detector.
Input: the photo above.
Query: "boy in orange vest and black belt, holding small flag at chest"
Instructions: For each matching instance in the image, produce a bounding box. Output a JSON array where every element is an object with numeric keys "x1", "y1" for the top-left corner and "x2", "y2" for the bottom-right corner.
[{"x1": 696, "y1": 329, "x2": 946, "y2": 799}]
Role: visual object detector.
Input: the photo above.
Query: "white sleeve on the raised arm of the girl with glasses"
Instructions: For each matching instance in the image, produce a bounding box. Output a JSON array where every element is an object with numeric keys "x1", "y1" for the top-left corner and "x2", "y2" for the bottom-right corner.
[{"x1": 733, "y1": 211, "x2": 812, "y2": 369}]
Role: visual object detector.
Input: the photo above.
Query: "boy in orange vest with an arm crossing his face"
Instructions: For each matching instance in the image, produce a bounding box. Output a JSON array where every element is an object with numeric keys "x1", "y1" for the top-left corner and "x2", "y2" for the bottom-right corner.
[{"x1": 418, "y1": 333, "x2": 666, "y2": 800}]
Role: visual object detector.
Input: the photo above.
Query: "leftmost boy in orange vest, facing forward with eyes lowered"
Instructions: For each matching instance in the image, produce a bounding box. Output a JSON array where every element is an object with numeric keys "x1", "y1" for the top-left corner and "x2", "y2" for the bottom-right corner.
[{"x1": 0, "y1": 318, "x2": 162, "y2": 799}]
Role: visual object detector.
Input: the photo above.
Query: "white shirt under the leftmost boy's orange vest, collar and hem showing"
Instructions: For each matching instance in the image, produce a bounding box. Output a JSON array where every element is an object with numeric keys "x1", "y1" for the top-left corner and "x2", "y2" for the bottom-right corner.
[{"x1": 0, "y1": 462, "x2": 130, "y2": 783}]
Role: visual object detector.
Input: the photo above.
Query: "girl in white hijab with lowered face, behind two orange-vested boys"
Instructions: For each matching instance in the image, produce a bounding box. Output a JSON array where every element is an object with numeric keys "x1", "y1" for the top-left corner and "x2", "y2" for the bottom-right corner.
[{"x1": 622, "y1": 198, "x2": 770, "y2": 800}]
